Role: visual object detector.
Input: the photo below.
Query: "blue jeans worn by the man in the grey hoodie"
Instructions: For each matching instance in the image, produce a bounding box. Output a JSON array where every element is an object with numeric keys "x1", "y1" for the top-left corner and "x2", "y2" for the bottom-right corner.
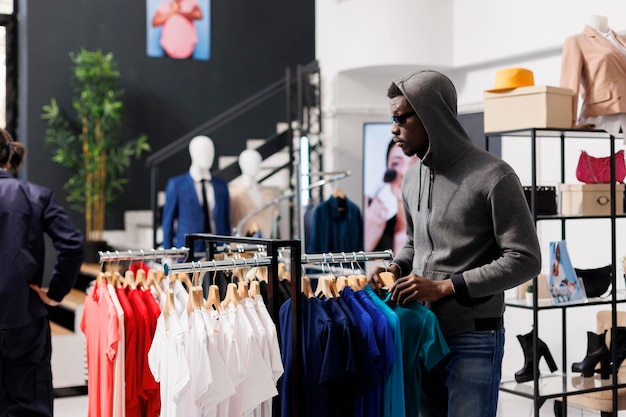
[{"x1": 420, "y1": 329, "x2": 504, "y2": 417}]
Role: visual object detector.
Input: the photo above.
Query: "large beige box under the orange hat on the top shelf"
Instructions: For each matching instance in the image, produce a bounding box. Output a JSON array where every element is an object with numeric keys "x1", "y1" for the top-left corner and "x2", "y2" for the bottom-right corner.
[{"x1": 484, "y1": 85, "x2": 573, "y2": 133}]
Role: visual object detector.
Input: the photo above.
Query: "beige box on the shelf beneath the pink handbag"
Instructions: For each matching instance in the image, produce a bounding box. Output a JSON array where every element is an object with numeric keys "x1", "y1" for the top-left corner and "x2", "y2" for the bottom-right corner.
[{"x1": 561, "y1": 184, "x2": 624, "y2": 216}]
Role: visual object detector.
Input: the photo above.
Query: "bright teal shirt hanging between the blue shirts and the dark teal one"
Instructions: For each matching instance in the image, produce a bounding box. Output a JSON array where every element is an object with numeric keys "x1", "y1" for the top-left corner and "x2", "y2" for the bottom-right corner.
[{"x1": 364, "y1": 285, "x2": 409, "y2": 417}]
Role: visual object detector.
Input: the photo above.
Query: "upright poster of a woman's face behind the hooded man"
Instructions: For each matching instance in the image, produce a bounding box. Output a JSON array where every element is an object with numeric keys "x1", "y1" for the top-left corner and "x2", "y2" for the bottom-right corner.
[{"x1": 363, "y1": 123, "x2": 418, "y2": 254}]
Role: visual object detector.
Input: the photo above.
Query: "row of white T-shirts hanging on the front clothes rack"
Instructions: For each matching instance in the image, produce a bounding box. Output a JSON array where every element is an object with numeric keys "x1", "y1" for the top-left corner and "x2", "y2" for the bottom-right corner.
[{"x1": 148, "y1": 281, "x2": 283, "y2": 417}]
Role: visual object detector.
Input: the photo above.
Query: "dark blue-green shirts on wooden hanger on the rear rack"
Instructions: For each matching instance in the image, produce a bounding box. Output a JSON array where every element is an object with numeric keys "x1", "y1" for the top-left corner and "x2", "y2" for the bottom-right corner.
[{"x1": 306, "y1": 189, "x2": 363, "y2": 253}]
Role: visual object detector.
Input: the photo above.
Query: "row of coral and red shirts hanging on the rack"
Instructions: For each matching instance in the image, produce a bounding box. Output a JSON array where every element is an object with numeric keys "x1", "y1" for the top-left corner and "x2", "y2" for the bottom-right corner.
[{"x1": 80, "y1": 271, "x2": 161, "y2": 417}]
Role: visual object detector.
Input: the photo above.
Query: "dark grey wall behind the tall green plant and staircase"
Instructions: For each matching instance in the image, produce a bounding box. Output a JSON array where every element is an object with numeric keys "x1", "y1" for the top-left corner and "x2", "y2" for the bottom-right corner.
[{"x1": 16, "y1": 0, "x2": 315, "y2": 229}]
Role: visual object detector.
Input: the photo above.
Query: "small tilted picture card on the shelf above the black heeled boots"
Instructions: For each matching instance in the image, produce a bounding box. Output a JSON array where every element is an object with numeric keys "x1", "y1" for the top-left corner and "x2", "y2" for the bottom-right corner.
[{"x1": 548, "y1": 240, "x2": 587, "y2": 304}]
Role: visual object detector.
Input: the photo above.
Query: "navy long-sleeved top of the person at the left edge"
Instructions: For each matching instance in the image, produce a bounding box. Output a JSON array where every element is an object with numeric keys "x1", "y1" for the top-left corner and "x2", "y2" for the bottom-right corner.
[{"x1": 0, "y1": 170, "x2": 84, "y2": 329}]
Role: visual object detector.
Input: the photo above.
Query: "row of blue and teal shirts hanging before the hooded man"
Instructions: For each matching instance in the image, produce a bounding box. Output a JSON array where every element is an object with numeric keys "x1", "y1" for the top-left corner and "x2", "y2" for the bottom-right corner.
[{"x1": 280, "y1": 284, "x2": 449, "y2": 417}]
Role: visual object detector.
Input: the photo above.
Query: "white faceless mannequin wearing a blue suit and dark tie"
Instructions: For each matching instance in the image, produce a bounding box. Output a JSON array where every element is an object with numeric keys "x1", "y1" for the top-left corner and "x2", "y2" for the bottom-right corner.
[{"x1": 163, "y1": 136, "x2": 230, "y2": 252}]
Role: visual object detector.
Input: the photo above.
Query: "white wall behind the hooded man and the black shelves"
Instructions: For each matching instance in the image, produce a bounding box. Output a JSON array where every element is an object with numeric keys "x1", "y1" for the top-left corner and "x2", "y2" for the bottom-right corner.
[{"x1": 316, "y1": 0, "x2": 626, "y2": 384}]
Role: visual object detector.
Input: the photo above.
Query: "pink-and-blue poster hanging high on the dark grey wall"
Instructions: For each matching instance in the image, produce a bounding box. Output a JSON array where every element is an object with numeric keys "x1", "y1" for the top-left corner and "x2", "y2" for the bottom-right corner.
[{"x1": 147, "y1": 0, "x2": 209, "y2": 60}]
